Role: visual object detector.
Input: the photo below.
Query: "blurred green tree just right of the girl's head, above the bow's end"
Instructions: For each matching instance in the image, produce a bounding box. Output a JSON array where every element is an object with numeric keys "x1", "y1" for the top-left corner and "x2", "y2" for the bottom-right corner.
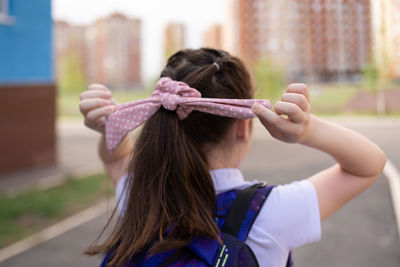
[{"x1": 252, "y1": 58, "x2": 286, "y2": 103}]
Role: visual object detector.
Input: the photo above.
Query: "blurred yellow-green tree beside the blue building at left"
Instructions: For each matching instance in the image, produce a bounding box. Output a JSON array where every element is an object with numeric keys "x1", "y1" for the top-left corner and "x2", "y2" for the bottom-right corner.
[{"x1": 58, "y1": 52, "x2": 87, "y2": 93}]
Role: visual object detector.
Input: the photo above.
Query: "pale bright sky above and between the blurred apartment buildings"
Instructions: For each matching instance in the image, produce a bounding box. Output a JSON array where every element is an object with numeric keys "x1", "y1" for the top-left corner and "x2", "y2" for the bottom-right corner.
[{"x1": 52, "y1": 0, "x2": 225, "y2": 81}]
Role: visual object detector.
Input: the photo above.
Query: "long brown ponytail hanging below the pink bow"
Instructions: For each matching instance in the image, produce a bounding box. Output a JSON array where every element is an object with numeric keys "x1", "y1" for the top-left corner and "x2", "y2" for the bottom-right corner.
[{"x1": 96, "y1": 108, "x2": 219, "y2": 266}]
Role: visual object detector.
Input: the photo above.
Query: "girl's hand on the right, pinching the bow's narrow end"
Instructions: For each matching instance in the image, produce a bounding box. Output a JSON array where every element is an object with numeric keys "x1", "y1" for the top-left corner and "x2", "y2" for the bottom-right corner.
[{"x1": 252, "y1": 83, "x2": 311, "y2": 143}]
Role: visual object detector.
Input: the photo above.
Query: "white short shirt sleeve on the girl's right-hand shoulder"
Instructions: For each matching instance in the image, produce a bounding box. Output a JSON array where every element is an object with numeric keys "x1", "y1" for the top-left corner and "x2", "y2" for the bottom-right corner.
[{"x1": 254, "y1": 180, "x2": 321, "y2": 249}]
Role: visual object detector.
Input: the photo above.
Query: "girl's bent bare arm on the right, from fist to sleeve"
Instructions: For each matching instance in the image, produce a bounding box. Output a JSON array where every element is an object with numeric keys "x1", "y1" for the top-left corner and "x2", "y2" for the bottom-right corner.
[{"x1": 253, "y1": 84, "x2": 386, "y2": 220}]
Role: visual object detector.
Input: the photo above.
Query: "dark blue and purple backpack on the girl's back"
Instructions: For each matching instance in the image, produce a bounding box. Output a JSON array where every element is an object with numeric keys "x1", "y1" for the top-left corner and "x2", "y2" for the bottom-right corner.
[{"x1": 100, "y1": 184, "x2": 292, "y2": 267}]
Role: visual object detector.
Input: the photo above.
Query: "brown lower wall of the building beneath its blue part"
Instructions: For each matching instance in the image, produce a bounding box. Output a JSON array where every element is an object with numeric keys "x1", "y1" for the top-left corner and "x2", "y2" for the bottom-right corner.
[{"x1": 0, "y1": 84, "x2": 56, "y2": 173}]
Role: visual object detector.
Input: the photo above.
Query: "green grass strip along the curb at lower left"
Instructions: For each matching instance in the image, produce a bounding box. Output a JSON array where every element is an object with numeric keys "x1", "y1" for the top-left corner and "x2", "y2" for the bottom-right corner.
[{"x1": 0, "y1": 174, "x2": 113, "y2": 248}]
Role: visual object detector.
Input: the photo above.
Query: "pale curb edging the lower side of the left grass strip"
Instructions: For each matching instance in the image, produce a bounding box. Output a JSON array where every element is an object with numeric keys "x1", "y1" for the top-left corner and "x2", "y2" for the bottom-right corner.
[{"x1": 0, "y1": 200, "x2": 115, "y2": 263}]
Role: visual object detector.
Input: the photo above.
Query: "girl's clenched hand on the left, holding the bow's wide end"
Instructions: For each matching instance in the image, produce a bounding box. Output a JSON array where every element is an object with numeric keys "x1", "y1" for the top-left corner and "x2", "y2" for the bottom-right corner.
[{"x1": 79, "y1": 84, "x2": 116, "y2": 134}]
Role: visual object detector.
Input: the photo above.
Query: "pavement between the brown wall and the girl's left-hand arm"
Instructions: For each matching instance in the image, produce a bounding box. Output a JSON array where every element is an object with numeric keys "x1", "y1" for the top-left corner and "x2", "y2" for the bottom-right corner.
[{"x1": 0, "y1": 120, "x2": 102, "y2": 193}]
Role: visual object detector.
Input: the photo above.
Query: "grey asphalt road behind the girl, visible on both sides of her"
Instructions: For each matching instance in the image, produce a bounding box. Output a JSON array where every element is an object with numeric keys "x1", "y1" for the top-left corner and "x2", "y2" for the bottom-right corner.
[{"x1": 0, "y1": 121, "x2": 400, "y2": 267}]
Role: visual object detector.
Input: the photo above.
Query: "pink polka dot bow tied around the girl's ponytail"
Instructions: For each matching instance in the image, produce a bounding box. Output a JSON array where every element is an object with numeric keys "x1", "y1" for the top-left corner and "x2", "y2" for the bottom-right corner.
[{"x1": 105, "y1": 77, "x2": 271, "y2": 151}]
